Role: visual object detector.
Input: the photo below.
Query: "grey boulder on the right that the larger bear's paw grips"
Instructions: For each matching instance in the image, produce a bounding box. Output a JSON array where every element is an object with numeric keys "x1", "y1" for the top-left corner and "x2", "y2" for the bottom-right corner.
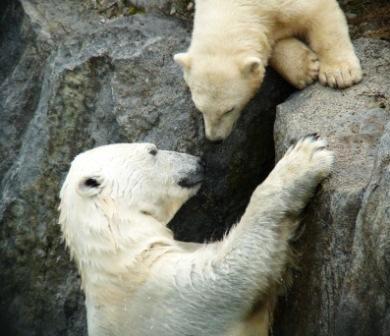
[{"x1": 274, "y1": 39, "x2": 390, "y2": 336}]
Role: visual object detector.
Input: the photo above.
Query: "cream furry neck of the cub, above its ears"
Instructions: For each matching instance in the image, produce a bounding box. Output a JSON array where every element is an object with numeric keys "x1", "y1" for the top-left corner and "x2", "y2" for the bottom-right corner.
[{"x1": 190, "y1": 0, "x2": 274, "y2": 64}]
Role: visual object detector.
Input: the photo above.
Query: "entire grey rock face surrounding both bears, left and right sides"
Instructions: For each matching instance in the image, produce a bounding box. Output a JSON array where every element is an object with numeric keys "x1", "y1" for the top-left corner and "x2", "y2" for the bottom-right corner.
[{"x1": 0, "y1": 0, "x2": 390, "y2": 336}]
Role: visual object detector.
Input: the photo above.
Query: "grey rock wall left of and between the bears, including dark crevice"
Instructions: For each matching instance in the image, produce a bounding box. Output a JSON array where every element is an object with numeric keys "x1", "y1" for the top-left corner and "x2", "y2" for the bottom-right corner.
[{"x1": 0, "y1": 0, "x2": 290, "y2": 336}]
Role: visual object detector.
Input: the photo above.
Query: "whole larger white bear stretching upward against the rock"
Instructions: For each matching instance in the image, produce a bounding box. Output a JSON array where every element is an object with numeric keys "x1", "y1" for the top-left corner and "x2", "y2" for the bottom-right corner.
[{"x1": 60, "y1": 136, "x2": 333, "y2": 336}]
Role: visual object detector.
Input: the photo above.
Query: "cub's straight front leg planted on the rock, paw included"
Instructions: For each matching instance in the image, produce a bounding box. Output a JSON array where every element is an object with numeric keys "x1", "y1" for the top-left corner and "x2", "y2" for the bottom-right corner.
[{"x1": 307, "y1": 0, "x2": 362, "y2": 88}]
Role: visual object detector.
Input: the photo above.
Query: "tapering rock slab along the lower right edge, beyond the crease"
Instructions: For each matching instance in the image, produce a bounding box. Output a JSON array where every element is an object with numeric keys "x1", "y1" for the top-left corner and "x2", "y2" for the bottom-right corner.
[{"x1": 335, "y1": 123, "x2": 390, "y2": 336}]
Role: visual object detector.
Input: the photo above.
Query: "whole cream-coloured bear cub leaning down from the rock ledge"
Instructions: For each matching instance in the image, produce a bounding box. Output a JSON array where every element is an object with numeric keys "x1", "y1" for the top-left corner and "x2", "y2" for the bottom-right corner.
[{"x1": 174, "y1": 0, "x2": 362, "y2": 141}]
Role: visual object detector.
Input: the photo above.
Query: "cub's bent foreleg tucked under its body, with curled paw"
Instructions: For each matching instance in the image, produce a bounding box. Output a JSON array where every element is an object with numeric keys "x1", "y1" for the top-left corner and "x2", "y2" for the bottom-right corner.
[{"x1": 270, "y1": 37, "x2": 320, "y2": 89}]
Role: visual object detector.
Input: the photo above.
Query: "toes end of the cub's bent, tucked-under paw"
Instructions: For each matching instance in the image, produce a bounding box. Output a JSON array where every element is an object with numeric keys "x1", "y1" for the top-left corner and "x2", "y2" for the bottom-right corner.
[{"x1": 291, "y1": 48, "x2": 320, "y2": 89}]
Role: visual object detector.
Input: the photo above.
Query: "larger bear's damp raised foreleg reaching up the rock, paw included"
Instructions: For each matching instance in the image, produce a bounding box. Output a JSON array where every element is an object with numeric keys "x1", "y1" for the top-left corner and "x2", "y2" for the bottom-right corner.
[{"x1": 214, "y1": 135, "x2": 334, "y2": 335}]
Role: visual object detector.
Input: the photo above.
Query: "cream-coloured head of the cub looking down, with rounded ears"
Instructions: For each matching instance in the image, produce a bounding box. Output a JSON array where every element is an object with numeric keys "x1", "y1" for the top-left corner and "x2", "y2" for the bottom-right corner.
[{"x1": 174, "y1": 53, "x2": 265, "y2": 141}]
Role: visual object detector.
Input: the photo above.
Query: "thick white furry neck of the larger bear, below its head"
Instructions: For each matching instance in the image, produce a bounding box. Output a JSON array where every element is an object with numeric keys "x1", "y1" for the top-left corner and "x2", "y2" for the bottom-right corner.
[{"x1": 65, "y1": 216, "x2": 174, "y2": 295}]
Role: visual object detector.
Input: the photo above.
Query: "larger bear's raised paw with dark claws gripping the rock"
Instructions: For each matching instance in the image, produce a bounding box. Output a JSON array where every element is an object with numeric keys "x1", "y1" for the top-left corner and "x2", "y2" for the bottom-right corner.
[{"x1": 282, "y1": 134, "x2": 334, "y2": 182}]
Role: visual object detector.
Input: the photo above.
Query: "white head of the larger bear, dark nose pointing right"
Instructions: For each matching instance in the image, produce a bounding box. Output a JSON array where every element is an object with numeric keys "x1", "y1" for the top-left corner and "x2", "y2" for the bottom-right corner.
[{"x1": 60, "y1": 143, "x2": 203, "y2": 251}]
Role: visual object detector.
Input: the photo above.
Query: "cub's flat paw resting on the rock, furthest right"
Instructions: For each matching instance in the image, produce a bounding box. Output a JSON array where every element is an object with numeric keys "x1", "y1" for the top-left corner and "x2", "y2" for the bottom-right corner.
[{"x1": 319, "y1": 55, "x2": 362, "y2": 89}]
